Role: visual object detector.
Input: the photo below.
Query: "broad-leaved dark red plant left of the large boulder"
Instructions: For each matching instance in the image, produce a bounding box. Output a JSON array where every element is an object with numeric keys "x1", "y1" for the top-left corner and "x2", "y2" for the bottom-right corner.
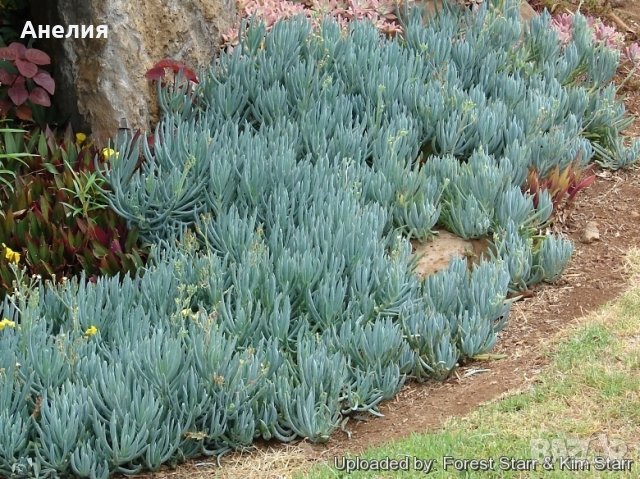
[{"x1": 0, "y1": 42, "x2": 56, "y2": 121}]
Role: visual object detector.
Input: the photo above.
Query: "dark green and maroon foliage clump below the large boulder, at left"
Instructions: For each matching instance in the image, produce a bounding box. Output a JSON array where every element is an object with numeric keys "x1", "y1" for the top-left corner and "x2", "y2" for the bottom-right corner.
[{"x1": 0, "y1": 128, "x2": 145, "y2": 295}]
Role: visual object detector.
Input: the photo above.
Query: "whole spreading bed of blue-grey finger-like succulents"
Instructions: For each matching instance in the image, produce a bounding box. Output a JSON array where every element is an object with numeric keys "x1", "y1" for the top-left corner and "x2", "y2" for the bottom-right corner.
[{"x1": 0, "y1": 2, "x2": 633, "y2": 477}]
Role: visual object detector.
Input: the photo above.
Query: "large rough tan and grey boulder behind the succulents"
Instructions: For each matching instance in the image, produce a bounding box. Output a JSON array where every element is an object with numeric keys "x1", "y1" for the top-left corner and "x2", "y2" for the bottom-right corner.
[{"x1": 31, "y1": 0, "x2": 235, "y2": 142}]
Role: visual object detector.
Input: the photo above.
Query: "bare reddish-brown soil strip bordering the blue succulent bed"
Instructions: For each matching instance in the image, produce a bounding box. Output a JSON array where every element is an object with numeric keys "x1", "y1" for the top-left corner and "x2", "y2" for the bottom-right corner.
[{"x1": 125, "y1": 0, "x2": 640, "y2": 478}]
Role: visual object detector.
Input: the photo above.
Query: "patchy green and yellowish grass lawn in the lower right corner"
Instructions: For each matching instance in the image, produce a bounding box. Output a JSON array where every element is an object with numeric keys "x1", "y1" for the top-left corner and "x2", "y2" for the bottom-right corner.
[{"x1": 296, "y1": 251, "x2": 640, "y2": 479}]
